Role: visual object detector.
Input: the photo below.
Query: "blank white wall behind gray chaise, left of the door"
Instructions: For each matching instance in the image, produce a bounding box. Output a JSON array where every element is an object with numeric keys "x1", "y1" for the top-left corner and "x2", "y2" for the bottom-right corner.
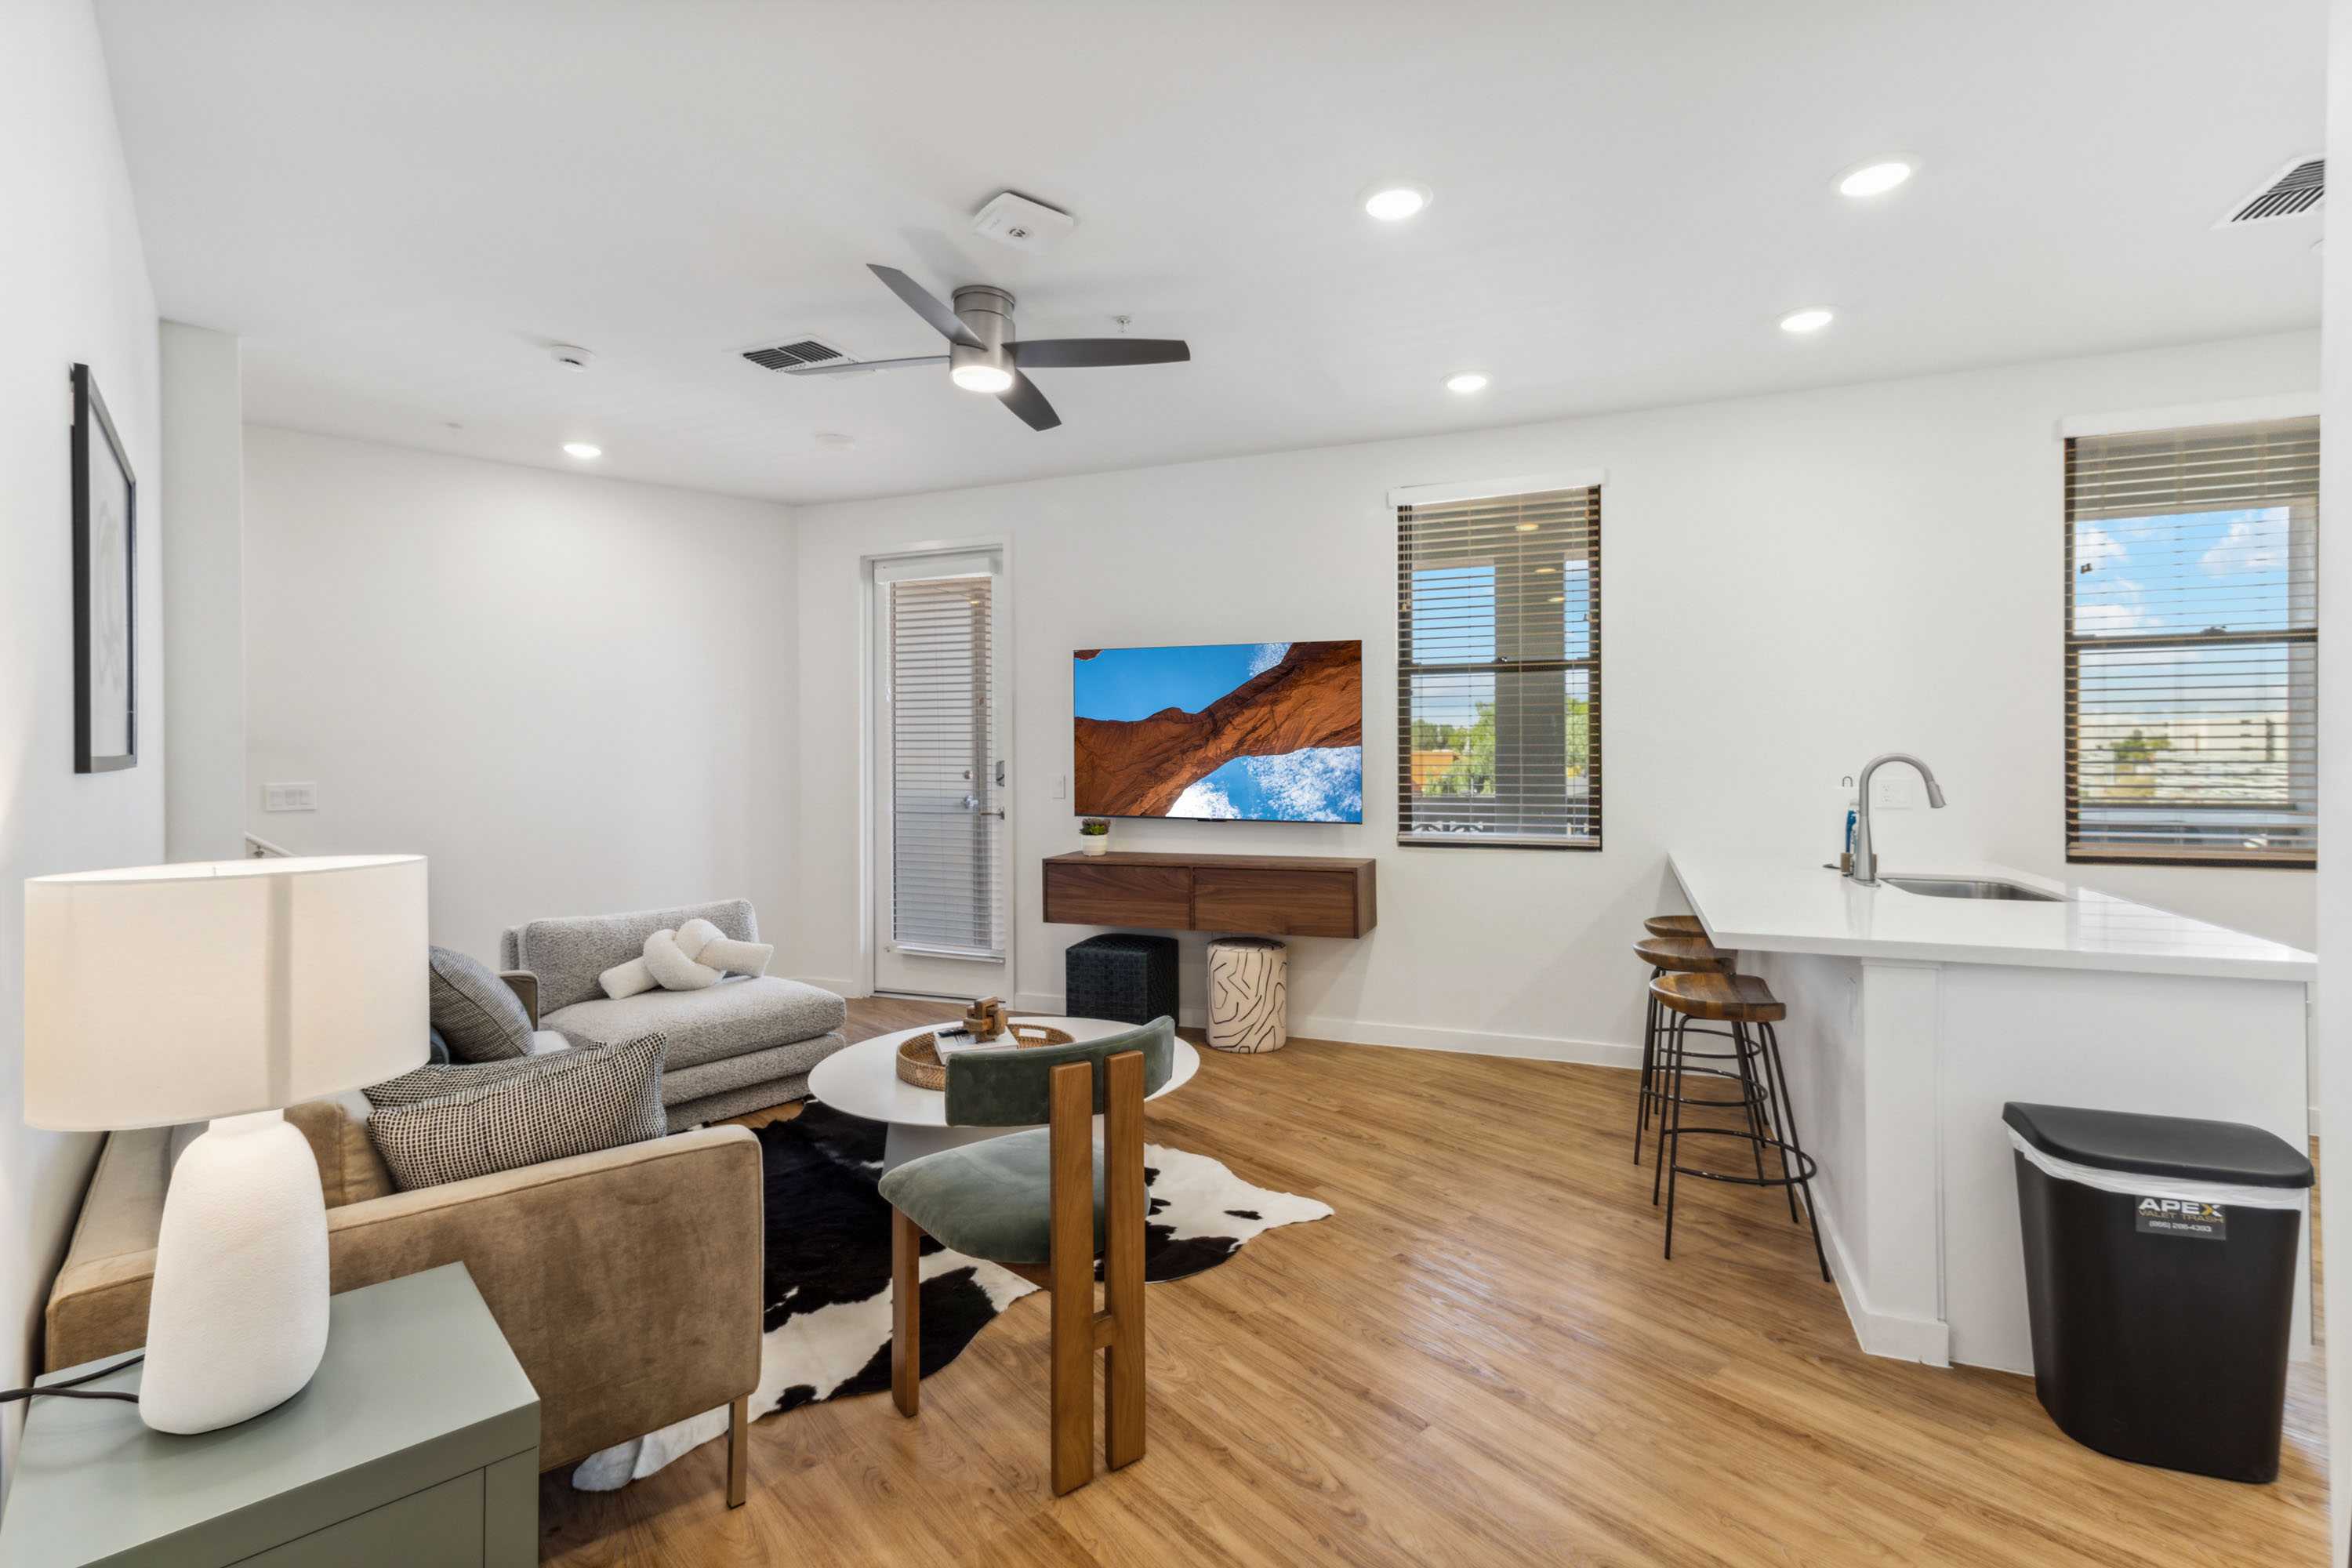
[{"x1": 245, "y1": 426, "x2": 800, "y2": 961}]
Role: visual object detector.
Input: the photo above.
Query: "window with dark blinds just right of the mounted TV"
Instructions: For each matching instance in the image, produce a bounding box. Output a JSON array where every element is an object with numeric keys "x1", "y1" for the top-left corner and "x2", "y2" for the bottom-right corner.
[{"x1": 1392, "y1": 480, "x2": 1602, "y2": 848}]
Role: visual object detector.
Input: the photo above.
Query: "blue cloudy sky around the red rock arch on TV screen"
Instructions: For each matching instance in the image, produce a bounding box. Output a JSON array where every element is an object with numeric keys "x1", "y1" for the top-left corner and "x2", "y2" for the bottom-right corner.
[{"x1": 1073, "y1": 642, "x2": 1364, "y2": 822}]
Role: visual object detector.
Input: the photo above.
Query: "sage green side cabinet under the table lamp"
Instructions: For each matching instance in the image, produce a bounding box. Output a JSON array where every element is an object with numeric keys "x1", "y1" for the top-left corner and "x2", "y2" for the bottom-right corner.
[{"x1": 0, "y1": 1262, "x2": 539, "y2": 1568}]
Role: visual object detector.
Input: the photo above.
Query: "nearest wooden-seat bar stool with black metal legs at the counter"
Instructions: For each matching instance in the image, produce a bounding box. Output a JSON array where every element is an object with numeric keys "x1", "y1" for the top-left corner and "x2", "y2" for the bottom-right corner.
[{"x1": 1649, "y1": 971, "x2": 1830, "y2": 1279}]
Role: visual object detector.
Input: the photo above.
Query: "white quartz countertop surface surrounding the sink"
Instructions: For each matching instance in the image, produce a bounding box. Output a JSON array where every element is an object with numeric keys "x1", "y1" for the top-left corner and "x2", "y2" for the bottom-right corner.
[{"x1": 1668, "y1": 851, "x2": 2317, "y2": 980}]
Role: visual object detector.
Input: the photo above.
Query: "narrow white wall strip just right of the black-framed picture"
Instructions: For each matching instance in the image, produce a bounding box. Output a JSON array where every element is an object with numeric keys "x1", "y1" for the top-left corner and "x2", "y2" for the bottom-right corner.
[{"x1": 155, "y1": 322, "x2": 245, "y2": 860}]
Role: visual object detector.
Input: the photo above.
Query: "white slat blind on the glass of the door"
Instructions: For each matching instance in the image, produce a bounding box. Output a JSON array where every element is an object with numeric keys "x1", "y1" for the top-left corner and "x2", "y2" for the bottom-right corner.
[{"x1": 889, "y1": 576, "x2": 1004, "y2": 959}]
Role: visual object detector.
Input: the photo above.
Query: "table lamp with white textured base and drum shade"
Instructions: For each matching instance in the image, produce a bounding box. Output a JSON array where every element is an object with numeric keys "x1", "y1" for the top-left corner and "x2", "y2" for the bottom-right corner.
[{"x1": 24, "y1": 855, "x2": 430, "y2": 1432}]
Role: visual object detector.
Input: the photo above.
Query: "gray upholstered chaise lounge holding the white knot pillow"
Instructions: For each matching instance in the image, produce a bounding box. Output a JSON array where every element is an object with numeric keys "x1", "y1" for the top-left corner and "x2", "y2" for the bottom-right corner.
[{"x1": 499, "y1": 898, "x2": 849, "y2": 1133}]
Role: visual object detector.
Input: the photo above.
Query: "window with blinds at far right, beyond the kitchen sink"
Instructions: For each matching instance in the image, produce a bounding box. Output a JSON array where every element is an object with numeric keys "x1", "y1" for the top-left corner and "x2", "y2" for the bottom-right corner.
[{"x1": 2065, "y1": 419, "x2": 2319, "y2": 865}]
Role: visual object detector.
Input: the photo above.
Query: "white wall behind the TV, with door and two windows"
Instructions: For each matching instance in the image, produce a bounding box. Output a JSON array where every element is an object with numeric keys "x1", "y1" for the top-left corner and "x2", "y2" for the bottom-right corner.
[{"x1": 795, "y1": 327, "x2": 2319, "y2": 1060}]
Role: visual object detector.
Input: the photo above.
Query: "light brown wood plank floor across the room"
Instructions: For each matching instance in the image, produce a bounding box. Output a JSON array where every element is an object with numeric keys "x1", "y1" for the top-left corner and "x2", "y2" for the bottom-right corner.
[{"x1": 541, "y1": 1001, "x2": 2326, "y2": 1568}]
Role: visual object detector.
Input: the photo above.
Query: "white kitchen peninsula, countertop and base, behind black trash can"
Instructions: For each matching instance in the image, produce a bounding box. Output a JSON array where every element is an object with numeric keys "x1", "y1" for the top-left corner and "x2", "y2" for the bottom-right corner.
[{"x1": 1670, "y1": 851, "x2": 2314, "y2": 1373}]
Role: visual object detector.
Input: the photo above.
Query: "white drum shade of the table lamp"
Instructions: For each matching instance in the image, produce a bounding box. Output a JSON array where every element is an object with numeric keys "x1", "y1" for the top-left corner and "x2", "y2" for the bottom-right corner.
[{"x1": 24, "y1": 855, "x2": 430, "y2": 1131}]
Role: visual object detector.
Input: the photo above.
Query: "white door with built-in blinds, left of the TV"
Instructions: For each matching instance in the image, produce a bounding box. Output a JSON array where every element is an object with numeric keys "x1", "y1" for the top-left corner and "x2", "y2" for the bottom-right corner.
[{"x1": 873, "y1": 553, "x2": 1011, "y2": 996}]
